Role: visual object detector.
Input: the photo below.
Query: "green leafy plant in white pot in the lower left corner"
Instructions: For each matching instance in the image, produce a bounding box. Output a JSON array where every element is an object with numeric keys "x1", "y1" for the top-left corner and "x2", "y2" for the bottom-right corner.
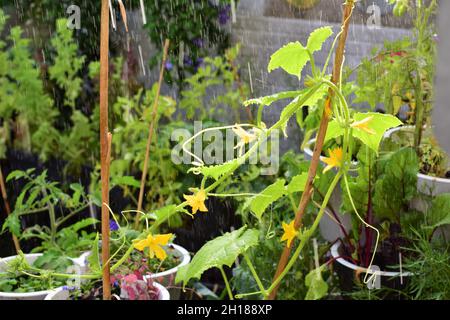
[{"x1": 0, "y1": 169, "x2": 98, "y2": 299}]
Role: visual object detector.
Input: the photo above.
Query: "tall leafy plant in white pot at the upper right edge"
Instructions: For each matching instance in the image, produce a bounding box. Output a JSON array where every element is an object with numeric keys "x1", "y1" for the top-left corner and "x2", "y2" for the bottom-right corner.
[{"x1": 355, "y1": 0, "x2": 450, "y2": 195}]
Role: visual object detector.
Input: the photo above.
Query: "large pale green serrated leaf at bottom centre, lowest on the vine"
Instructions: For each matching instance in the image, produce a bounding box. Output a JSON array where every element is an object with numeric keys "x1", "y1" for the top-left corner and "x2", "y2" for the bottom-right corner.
[{"x1": 175, "y1": 226, "x2": 259, "y2": 284}]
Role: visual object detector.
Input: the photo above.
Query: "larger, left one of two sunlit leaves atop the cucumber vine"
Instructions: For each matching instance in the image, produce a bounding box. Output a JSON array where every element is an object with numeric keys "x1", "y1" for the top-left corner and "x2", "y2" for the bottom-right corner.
[{"x1": 268, "y1": 41, "x2": 309, "y2": 80}]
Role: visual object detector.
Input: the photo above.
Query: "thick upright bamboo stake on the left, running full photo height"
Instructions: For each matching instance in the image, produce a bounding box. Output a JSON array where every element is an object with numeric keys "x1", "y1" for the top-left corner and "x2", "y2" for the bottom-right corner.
[{"x1": 100, "y1": 0, "x2": 111, "y2": 300}]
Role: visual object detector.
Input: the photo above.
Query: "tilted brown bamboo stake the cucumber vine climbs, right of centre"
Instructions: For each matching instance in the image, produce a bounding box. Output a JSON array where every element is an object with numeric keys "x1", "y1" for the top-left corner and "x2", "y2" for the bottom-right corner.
[{"x1": 268, "y1": 0, "x2": 355, "y2": 300}]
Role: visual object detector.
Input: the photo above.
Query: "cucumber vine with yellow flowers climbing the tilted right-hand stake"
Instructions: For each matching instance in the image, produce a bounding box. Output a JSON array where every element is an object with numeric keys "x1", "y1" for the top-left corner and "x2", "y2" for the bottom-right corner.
[{"x1": 166, "y1": 0, "x2": 399, "y2": 299}]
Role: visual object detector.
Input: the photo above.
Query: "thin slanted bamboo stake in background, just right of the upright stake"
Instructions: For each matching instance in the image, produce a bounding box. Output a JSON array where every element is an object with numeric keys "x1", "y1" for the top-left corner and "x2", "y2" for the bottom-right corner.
[{"x1": 134, "y1": 39, "x2": 170, "y2": 229}]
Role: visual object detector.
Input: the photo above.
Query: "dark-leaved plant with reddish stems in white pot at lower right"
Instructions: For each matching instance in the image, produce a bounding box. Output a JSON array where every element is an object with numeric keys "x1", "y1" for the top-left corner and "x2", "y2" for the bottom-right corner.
[{"x1": 331, "y1": 148, "x2": 450, "y2": 291}]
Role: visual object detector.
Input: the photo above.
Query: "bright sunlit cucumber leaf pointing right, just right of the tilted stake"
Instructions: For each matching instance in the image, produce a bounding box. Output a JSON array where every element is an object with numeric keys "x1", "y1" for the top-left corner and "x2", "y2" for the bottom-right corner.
[{"x1": 353, "y1": 112, "x2": 402, "y2": 154}]
